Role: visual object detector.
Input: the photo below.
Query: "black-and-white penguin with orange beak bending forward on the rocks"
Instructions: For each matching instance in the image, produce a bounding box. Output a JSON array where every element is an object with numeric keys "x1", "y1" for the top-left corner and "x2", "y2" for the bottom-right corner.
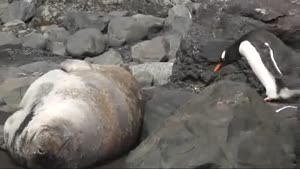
[{"x1": 214, "y1": 29, "x2": 300, "y2": 101}]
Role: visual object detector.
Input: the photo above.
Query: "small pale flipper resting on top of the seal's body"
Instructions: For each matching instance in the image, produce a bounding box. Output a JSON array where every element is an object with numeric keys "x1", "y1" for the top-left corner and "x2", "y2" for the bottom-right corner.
[{"x1": 60, "y1": 59, "x2": 92, "y2": 72}]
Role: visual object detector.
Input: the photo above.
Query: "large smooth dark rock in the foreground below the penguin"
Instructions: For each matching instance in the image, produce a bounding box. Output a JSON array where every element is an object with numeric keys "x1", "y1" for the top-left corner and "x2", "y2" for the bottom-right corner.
[{"x1": 126, "y1": 81, "x2": 295, "y2": 168}]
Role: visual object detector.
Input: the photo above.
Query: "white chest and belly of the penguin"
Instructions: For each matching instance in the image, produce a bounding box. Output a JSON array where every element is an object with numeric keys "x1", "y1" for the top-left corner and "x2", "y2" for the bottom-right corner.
[{"x1": 239, "y1": 41, "x2": 278, "y2": 98}]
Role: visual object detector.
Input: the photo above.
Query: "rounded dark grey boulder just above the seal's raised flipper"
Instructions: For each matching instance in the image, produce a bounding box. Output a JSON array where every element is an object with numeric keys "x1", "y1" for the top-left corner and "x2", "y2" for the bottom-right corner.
[{"x1": 66, "y1": 28, "x2": 106, "y2": 59}]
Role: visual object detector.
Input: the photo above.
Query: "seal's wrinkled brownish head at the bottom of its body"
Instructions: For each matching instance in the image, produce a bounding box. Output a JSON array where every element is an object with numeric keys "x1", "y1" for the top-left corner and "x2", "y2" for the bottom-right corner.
[{"x1": 21, "y1": 126, "x2": 72, "y2": 168}]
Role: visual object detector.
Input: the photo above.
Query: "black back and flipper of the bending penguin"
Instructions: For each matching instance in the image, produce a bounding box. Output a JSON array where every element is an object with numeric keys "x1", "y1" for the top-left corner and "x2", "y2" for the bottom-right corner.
[{"x1": 226, "y1": 29, "x2": 300, "y2": 77}]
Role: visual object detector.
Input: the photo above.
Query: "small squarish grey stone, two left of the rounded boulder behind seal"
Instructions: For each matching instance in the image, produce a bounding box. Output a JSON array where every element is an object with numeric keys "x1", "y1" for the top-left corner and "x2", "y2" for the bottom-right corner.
[{"x1": 22, "y1": 33, "x2": 47, "y2": 49}]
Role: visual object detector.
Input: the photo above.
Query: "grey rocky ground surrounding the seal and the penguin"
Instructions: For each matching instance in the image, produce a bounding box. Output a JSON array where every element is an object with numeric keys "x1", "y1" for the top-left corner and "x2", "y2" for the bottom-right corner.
[{"x1": 0, "y1": 0, "x2": 300, "y2": 168}]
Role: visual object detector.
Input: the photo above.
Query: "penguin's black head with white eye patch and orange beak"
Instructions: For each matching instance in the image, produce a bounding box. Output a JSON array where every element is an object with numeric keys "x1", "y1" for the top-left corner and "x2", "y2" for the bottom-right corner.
[{"x1": 214, "y1": 44, "x2": 242, "y2": 72}]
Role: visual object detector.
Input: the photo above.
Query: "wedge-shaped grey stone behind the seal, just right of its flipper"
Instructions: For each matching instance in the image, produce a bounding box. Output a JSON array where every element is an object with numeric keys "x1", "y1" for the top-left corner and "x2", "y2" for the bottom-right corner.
[{"x1": 85, "y1": 49, "x2": 124, "y2": 65}]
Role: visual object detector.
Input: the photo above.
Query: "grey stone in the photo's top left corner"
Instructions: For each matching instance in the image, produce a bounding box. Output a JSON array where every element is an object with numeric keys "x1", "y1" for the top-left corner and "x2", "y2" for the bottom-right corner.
[{"x1": 1, "y1": 1, "x2": 35, "y2": 23}]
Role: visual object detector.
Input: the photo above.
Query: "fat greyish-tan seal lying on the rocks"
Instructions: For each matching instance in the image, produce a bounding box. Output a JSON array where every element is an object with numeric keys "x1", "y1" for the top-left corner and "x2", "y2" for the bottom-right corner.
[{"x1": 4, "y1": 59, "x2": 144, "y2": 168}]
